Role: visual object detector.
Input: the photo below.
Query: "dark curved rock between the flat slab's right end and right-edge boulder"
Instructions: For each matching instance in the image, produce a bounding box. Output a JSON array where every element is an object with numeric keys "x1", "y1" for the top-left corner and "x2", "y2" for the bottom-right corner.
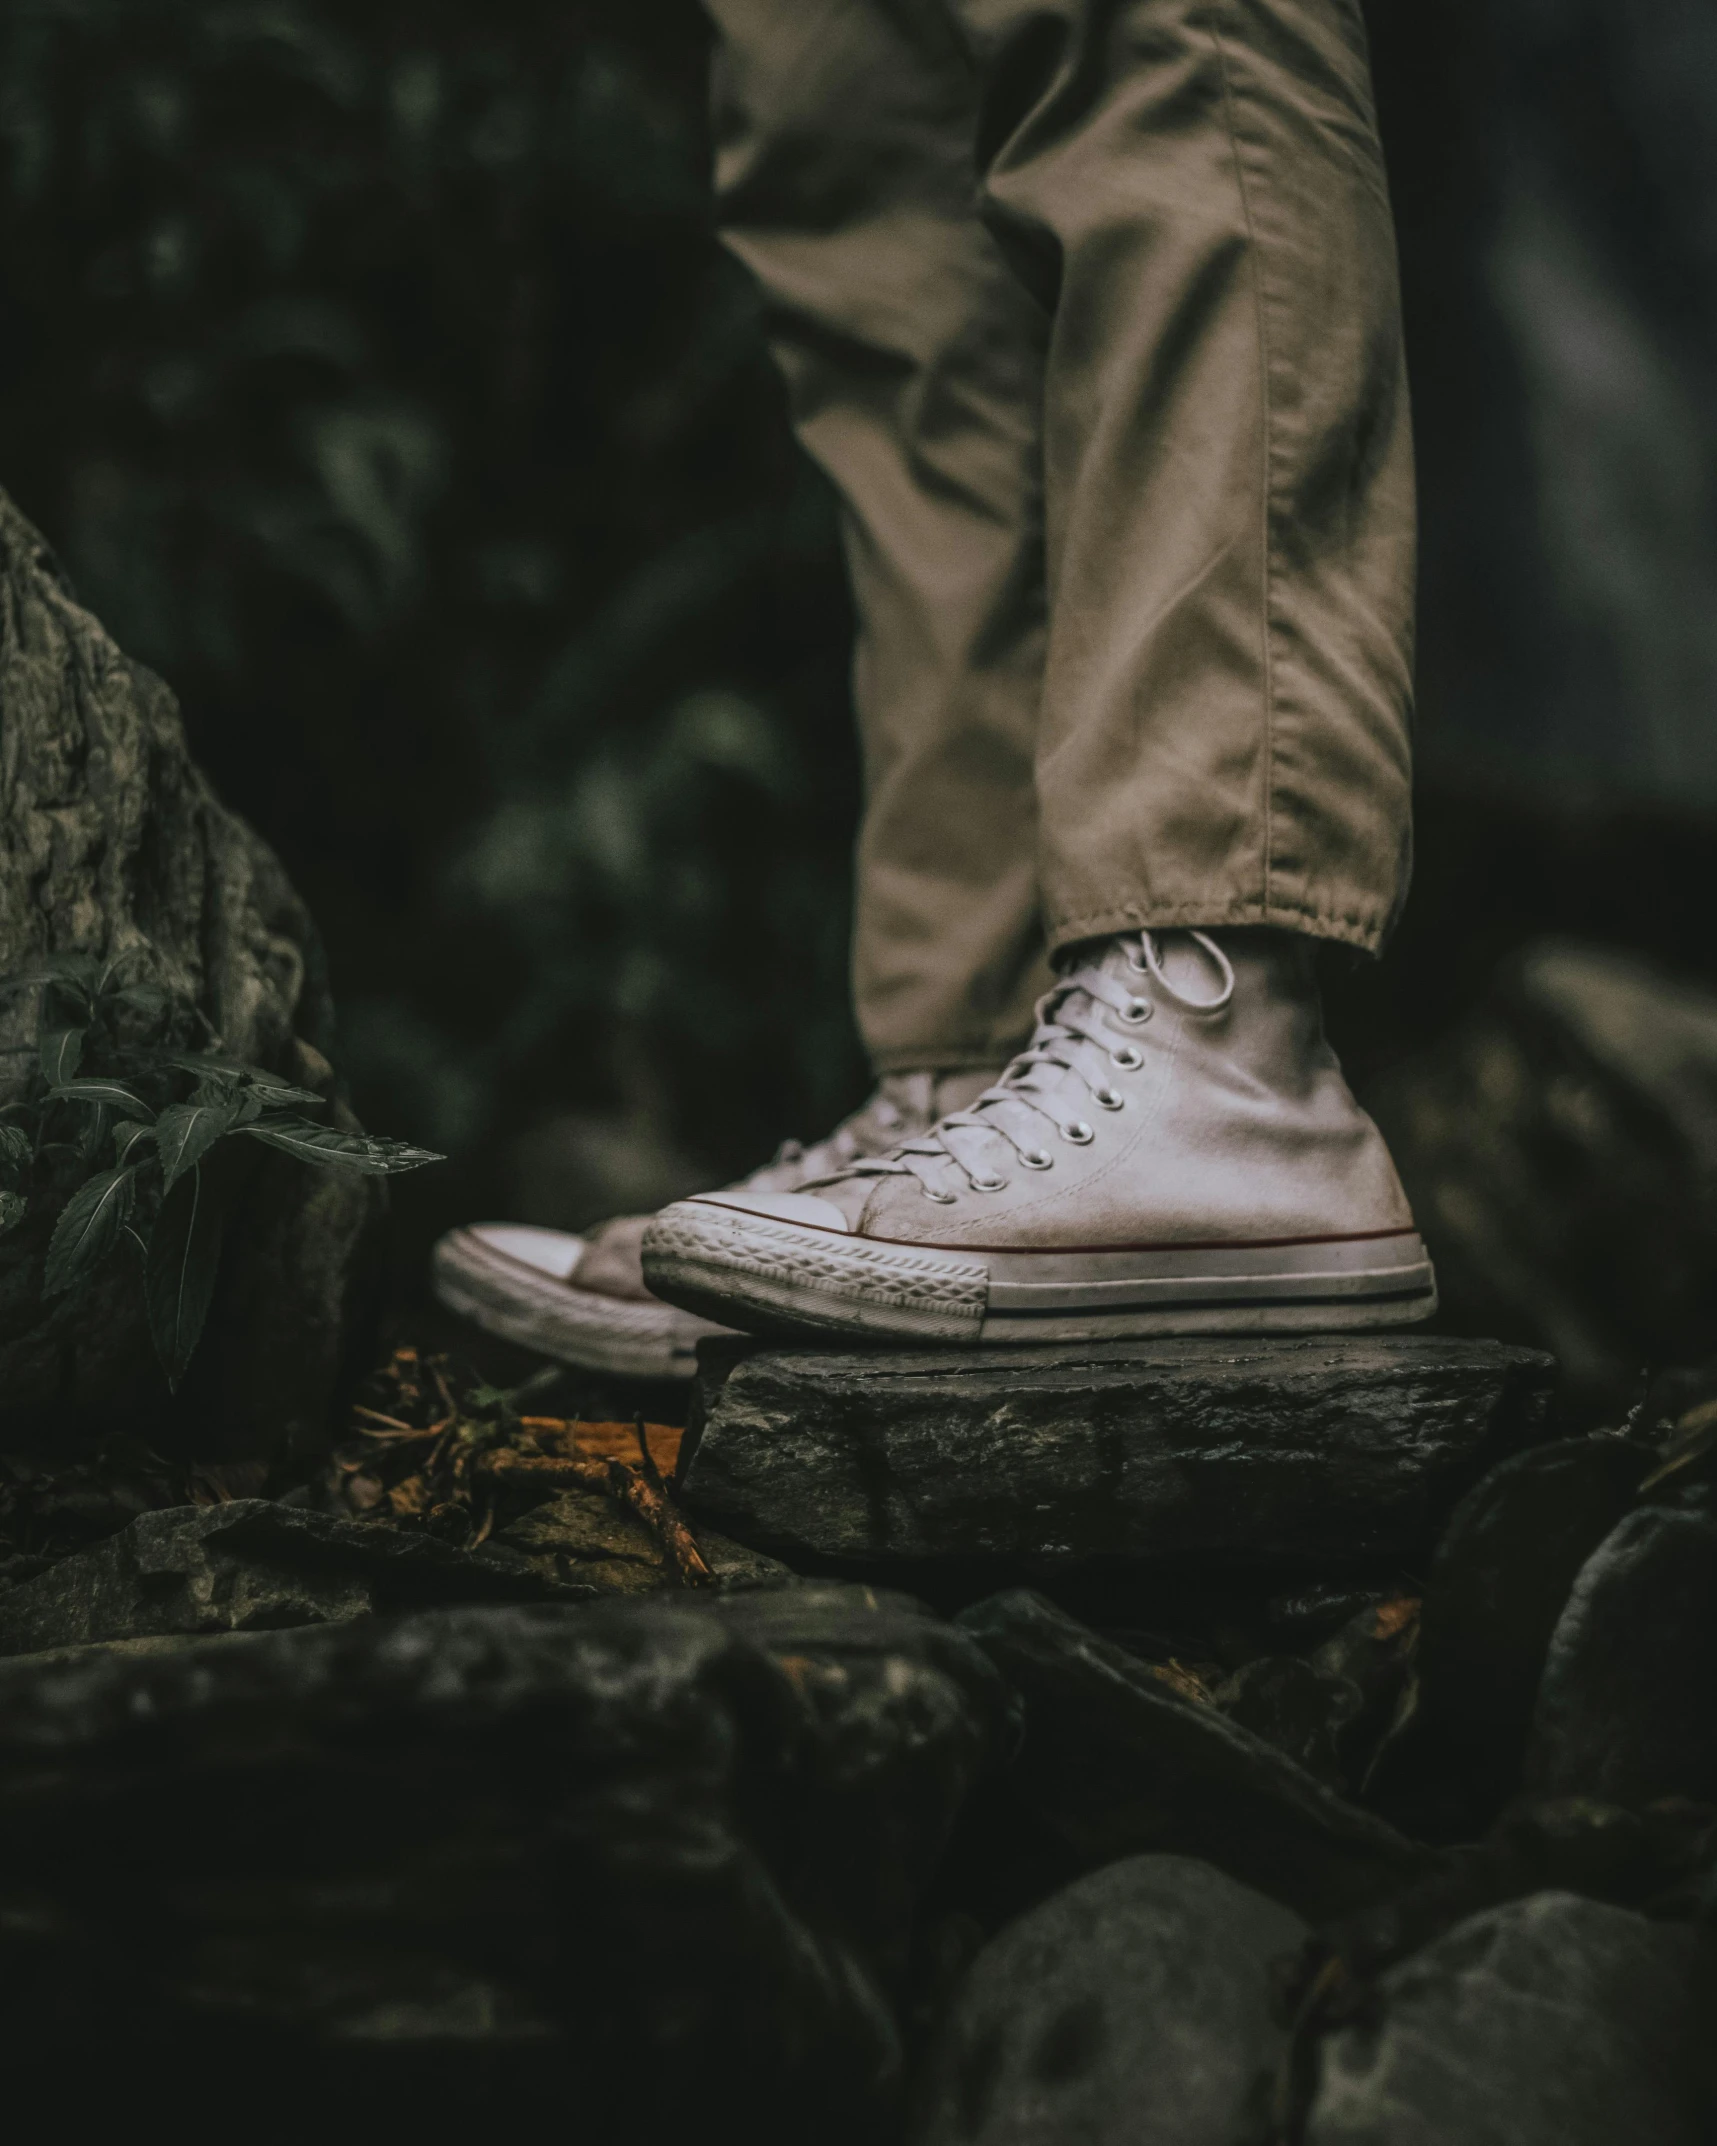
[{"x1": 1376, "y1": 1434, "x2": 1650, "y2": 1835}]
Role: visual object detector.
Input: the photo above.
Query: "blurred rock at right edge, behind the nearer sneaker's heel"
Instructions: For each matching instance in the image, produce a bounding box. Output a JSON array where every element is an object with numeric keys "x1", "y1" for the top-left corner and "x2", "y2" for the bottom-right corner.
[{"x1": 1367, "y1": 940, "x2": 1717, "y2": 1421}]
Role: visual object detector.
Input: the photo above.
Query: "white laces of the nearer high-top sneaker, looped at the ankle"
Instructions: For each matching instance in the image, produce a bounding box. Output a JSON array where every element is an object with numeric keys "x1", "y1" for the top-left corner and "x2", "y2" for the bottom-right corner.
[{"x1": 828, "y1": 931, "x2": 1234, "y2": 1206}]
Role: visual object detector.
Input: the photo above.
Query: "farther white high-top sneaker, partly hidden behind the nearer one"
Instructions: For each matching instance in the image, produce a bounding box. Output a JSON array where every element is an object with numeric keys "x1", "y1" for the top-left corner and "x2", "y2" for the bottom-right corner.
[{"x1": 434, "y1": 1071, "x2": 996, "y2": 1378}]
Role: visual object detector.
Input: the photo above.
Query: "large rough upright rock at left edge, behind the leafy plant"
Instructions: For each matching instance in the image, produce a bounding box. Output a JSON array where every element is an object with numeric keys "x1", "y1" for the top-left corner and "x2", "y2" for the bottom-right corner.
[{"x1": 0, "y1": 494, "x2": 382, "y2": 1459}]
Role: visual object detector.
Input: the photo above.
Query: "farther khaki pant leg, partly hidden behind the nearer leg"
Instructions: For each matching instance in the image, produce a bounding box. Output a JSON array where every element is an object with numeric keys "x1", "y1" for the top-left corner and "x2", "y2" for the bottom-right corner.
[{"x1": 708, "y1": 0, "x2": 1050, "y2": 1071}]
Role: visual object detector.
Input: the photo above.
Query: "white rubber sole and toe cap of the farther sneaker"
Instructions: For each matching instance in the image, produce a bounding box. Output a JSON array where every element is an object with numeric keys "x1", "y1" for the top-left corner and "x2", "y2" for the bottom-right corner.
[{"x1": 431, "y1": 1230, "x2": 732, "y2": 1378}]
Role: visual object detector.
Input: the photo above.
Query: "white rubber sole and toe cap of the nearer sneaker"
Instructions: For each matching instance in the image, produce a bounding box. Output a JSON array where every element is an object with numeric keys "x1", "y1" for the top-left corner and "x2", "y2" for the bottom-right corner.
[{"x1": 644, "y1": 1200, "x2": 1436, "y2": 1343}]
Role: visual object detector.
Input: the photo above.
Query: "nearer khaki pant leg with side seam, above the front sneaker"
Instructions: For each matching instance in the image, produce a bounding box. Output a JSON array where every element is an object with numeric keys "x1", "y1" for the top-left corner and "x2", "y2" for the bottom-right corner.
[{"x1": 951, "y1": 0, "x2": 1414, "y2": 949}]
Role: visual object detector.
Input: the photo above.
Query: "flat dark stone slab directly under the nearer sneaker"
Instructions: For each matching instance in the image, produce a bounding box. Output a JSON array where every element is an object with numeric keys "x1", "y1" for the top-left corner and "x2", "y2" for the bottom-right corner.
[{"x1": 680, "y1": 1335, "x2": 1556, "y2": 1569}]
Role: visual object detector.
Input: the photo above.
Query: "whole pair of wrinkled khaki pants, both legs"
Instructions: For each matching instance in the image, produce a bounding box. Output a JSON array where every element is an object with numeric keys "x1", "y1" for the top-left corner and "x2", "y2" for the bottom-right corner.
[{"x1": 710, "y1": 0, "x2": 1414, "y2": 1069}]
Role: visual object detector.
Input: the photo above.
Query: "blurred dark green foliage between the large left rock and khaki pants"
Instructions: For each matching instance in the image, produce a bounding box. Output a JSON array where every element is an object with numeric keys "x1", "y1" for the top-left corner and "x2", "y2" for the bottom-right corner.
[{"x1": 0, "y1": 0, "x2": 859, "y2": 1253}]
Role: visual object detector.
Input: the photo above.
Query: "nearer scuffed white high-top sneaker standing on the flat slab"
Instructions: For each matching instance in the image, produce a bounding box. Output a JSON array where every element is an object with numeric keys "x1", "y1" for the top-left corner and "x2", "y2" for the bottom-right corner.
[{"x1": 644, "y1": 931, "x2": 1436, "y2": 1341}]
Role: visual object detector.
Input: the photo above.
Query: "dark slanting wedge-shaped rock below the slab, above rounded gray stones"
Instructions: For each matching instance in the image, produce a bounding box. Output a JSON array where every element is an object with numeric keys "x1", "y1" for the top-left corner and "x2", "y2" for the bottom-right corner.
[{"x1": 959, "y1": 1590, "x2": 1432, "y2": 1921}]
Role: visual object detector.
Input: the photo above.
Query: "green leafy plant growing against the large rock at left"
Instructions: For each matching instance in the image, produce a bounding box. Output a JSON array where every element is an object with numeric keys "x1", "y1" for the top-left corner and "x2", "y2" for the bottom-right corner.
[{"x1": 0, "y1": 955, "x2": 442, "y2": 1388}]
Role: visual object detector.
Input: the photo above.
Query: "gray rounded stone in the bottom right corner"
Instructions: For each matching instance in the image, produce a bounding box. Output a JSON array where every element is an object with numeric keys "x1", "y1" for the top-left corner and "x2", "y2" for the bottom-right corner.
[{"x1": 1305, "y1": 1893, "x2": 1717, "y2": 2146}]
